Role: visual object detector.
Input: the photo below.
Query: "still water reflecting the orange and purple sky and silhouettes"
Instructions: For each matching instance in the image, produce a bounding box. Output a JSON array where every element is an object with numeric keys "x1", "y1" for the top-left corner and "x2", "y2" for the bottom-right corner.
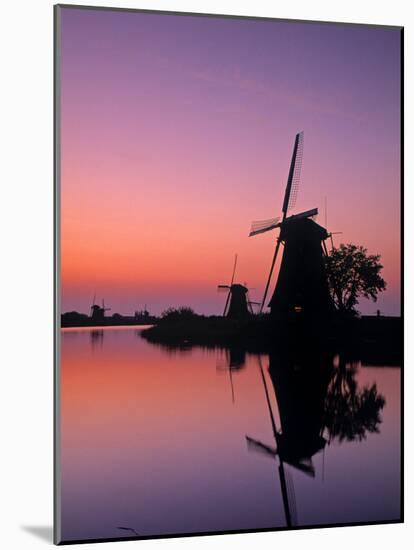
[{"x1": 61, "y1": 327, "x2": 400, "y2": 540}]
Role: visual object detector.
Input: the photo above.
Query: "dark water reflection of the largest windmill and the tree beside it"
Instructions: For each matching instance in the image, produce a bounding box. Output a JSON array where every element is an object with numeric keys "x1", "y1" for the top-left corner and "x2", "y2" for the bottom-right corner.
[{"x1": 246, "y1": 342, "x2": 385, "y2": 527}]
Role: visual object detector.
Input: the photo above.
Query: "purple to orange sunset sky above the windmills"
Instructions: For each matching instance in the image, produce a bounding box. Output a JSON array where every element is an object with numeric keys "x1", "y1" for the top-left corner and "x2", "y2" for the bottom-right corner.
[{"x1": 60, "y1": 8, "x2": 400, "y2": 315}]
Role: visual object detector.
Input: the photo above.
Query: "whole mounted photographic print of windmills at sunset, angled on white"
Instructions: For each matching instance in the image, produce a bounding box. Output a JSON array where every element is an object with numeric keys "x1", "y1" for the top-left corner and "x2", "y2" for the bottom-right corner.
[{"x1": 55, "y1": 5, "x2": 403, "y2": 543}]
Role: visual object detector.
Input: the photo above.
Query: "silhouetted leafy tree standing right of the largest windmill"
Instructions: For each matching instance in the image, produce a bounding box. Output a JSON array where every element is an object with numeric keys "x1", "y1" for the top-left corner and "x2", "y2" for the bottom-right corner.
[{"x1": 326, "y1": 244, "x2": 387, "y2": 313}]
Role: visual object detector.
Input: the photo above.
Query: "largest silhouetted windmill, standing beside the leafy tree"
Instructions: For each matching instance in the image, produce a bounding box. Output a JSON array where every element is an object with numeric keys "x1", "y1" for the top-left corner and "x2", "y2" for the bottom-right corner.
[{"x1": 249, "y1": 132, "x2": 331, "y2": 318}]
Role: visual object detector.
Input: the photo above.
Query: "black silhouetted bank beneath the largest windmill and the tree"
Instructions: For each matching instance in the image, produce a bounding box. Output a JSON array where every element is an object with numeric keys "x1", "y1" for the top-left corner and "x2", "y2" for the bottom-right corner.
[{"x1": 141, "y1": 316, "x2": 403, "y2": 365}]
